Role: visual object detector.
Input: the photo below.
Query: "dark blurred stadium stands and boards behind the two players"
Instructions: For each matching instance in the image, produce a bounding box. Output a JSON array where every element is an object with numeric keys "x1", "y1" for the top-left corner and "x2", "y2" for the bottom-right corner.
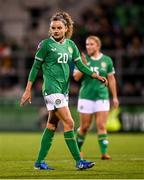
[{"x1": 0, "y1": 0, "x2": 144, "y2": 132}]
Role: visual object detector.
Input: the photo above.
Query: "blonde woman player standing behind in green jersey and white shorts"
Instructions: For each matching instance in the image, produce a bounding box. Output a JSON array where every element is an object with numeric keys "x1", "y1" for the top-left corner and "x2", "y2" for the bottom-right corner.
[{"x1": 73, "y1": 36, "x2": 119, "y2": 159}]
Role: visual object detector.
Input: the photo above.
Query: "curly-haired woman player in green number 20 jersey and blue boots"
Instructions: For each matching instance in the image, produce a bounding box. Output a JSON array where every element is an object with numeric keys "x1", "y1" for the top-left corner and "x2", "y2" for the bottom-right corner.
[{"x1": 20, "y1": 12, "x2": 107, "y2": 170}]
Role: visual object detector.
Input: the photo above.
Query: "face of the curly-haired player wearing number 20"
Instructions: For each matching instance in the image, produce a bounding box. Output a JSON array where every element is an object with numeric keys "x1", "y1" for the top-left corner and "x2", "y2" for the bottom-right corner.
[{"x1": 50, "y1": 21, "x2": 67, "y2": 42}]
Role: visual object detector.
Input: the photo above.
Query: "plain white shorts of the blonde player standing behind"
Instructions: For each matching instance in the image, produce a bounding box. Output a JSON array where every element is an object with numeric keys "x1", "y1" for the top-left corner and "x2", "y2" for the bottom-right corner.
[{"x1": 77, "y1": 99, "x2": 110, "y2": 114}]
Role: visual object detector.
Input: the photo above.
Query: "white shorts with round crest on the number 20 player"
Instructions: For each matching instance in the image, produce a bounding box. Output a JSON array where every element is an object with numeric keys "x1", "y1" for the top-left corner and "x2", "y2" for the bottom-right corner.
[{"x1": 44, "y1": 93, "x2": 68, "y2": 111}]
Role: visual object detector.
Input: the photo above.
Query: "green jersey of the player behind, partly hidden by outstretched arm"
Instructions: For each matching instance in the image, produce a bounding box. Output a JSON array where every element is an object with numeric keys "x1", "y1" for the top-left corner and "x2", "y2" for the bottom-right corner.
[{"x1": 79, "y1": 54, "x2": 115, "y2": 100}]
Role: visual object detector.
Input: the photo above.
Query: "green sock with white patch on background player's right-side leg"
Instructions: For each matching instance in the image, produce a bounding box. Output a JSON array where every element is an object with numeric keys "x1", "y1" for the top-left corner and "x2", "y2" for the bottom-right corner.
[{"x1": 98, "y1": 134, "x2": 108, "y2": 154}]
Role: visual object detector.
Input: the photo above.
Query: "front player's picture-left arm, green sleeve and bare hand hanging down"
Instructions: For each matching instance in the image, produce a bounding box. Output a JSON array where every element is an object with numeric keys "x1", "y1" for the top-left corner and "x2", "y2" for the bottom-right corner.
[{"x1": 20, "y1": 42, "x2": 46, "y2": 106}]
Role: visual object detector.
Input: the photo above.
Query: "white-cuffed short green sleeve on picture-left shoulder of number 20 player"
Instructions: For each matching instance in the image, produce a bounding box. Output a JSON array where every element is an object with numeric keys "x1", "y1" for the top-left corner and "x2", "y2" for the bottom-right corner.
[{"x1": 35, "y1": 40, "x2": 46, "y2": 61}]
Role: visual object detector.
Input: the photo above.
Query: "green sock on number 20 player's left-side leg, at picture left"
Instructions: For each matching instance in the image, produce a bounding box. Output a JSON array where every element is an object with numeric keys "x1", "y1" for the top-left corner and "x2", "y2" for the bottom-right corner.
[{"x1": 37, "y1": 128, "x2": 54, "y2": 163}]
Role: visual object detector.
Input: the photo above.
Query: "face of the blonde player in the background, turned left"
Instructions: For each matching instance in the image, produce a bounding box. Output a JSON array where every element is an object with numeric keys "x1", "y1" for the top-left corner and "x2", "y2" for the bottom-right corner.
[{"x1": 86, "y1": 39, "x2": 100, "y2": 56}]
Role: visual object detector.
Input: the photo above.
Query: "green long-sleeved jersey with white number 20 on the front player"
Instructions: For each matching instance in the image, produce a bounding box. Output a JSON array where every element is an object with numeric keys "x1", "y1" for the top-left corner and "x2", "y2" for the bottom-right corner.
[{"x1": 29, "y1": 37, "x2": 93, "y2": 95}]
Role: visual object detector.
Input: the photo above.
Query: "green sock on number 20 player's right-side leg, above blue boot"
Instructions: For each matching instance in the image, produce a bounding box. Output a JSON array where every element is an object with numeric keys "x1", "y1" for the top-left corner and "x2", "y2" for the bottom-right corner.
[{"x1": 64, "y1": 131, "x2": 81, "y2": 162}]
